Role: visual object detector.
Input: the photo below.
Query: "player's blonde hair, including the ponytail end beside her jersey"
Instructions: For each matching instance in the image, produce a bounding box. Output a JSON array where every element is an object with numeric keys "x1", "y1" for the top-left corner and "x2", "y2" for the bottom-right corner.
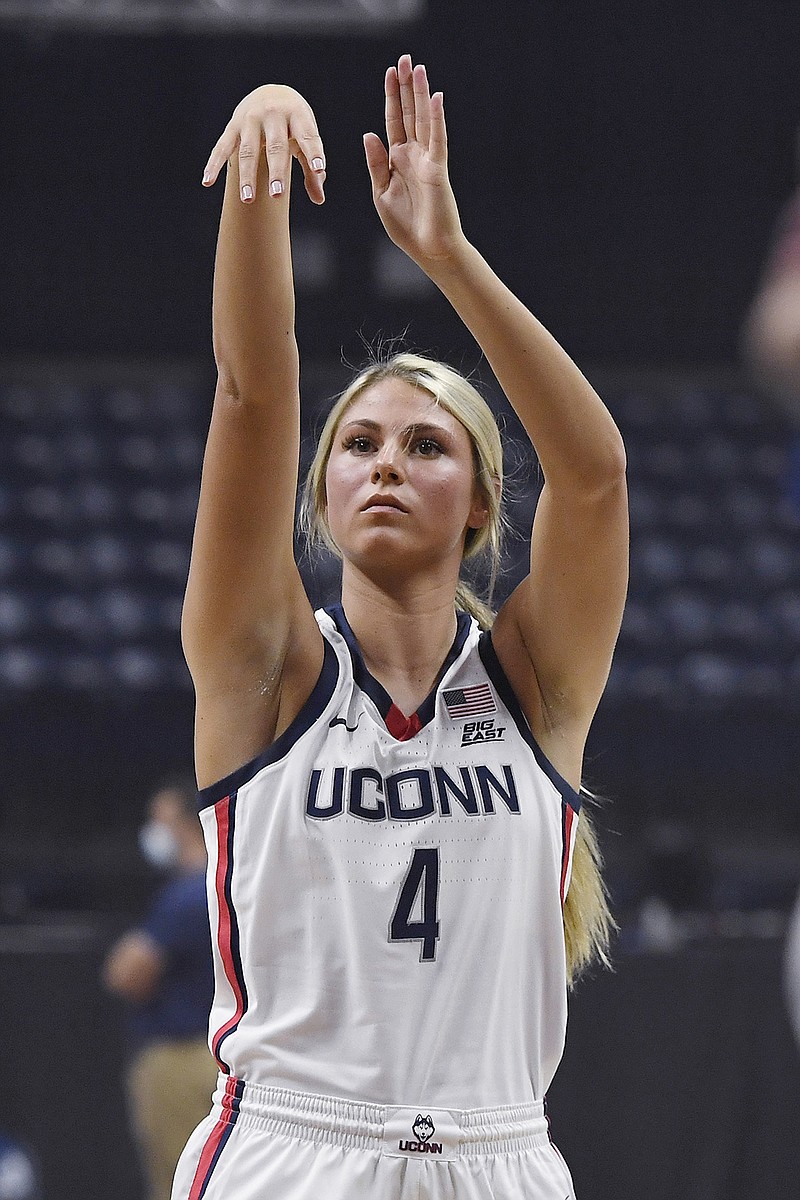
[{"x1": 300, "y1": 352, "x2": 615, "y2": 985}]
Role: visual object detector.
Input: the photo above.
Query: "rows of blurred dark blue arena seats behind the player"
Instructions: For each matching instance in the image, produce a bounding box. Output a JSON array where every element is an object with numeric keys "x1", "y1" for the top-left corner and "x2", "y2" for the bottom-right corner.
[{"x1": 0, "y1": 376, "x2": 800, "y2": 709}]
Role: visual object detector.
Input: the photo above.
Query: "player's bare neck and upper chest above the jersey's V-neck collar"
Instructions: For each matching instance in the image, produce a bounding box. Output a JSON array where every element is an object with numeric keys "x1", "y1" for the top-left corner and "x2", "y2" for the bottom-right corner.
[{"x1": 342, "y1": 563, "x2": 457, "y2": 715}]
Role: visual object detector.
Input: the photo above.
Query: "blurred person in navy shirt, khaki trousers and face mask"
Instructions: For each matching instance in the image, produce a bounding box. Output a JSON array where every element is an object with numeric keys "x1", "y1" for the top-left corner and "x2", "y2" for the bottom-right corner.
[{"x1": 103, "y1": 779, "x2": 216, "y2": 1200}]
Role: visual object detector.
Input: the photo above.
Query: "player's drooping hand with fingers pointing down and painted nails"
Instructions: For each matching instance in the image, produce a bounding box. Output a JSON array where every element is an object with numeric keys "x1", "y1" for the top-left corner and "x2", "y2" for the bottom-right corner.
[{"x1": 203, "y1": 84, "x2": 325, "y2": 204}]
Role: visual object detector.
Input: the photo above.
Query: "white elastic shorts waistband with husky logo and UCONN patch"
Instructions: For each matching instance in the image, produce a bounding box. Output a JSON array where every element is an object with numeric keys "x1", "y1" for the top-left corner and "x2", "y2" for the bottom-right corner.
[{"x1": 213, "y1": 1074, "x2": 549, "y2": 1159}]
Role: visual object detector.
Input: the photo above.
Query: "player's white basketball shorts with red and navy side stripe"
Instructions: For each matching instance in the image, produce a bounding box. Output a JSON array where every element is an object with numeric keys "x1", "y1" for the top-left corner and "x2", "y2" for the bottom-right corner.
[{"x1": 172, "y1": 1075, "x2": 575, "y2": 1200}]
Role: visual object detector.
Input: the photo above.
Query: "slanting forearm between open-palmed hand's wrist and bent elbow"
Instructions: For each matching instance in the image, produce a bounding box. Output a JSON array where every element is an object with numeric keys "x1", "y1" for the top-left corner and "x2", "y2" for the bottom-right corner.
[{"x1": 425, "y1": 240, "x2": 625, "y2": 491}]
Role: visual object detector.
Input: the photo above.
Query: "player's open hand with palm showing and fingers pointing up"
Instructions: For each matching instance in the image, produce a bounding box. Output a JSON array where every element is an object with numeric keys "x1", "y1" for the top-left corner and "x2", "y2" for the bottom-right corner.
[{"x1": 363, "y1": 54, "x2": 463, "y2": 269}]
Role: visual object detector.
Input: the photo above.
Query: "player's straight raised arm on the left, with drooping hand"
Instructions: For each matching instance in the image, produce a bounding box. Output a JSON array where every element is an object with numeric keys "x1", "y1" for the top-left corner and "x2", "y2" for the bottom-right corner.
[{"x1": 182, "y1": 85, "x2": 324, "y2": 786}]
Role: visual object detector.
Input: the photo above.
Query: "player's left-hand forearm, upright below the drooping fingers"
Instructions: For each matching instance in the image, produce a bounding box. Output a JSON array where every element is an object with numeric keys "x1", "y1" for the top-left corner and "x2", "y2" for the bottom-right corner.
[{"x1": 212, "y1": 155, "x2": 299, "y2": 401}]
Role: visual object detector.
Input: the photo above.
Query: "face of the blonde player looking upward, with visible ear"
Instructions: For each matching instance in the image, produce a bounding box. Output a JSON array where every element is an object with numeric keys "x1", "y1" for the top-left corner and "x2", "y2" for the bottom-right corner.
[{"x1": 325, "y1": 379, "x2": 487, "y2": 572}]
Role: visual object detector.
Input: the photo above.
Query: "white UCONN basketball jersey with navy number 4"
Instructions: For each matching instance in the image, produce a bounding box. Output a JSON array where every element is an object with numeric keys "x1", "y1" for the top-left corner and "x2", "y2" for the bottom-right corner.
[{"x1": 200, "y1": 606, "x2": 579, "y2": 1109}]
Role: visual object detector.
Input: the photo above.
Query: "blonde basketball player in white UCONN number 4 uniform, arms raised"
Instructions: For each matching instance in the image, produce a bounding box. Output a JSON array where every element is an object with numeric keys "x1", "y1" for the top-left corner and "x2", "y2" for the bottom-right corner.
[{"x1": 173, "y1": 55, "x2": 627, "y2": 1200}]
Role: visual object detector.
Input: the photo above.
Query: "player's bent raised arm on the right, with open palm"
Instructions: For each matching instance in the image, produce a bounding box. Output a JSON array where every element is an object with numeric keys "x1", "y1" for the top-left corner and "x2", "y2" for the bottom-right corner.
[{"x1": 365, "y1": 56, "x2": 627, "y2": 786}]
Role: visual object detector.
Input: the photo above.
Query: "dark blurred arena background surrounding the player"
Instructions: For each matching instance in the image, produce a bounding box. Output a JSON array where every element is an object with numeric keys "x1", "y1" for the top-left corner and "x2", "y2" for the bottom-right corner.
[{"x1": 0, "y1": 0, "x2": 800, "y2": 1200}]
